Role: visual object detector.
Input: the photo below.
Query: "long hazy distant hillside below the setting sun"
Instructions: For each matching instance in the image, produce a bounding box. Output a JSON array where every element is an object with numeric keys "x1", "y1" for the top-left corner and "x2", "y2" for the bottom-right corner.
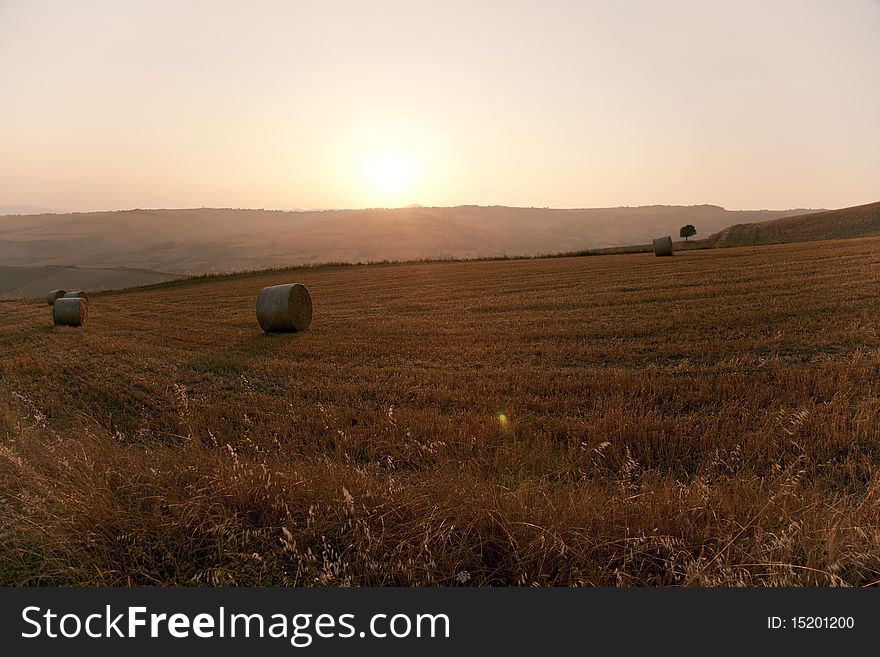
[{"x1": 0, "y1": 205, "x2": 820, "y2": 294}]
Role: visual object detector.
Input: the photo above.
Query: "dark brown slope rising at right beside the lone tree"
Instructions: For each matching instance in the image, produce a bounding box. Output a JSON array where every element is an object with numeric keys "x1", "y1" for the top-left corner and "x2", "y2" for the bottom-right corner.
[{"x1": 705, "y1": 203, "x2": 880, "y2": 246}]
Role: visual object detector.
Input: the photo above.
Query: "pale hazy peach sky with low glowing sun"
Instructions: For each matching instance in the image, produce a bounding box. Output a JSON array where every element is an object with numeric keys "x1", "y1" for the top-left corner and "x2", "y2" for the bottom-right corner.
[{"x1": 0, "y1": 0, "x2": 880, "y2": 210}]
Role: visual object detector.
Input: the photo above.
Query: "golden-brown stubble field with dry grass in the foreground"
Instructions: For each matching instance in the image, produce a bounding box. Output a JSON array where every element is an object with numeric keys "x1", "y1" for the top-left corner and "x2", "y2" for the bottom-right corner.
[{"x1": 0, "y1": 238, "x2": 880, "y2": 586}]
